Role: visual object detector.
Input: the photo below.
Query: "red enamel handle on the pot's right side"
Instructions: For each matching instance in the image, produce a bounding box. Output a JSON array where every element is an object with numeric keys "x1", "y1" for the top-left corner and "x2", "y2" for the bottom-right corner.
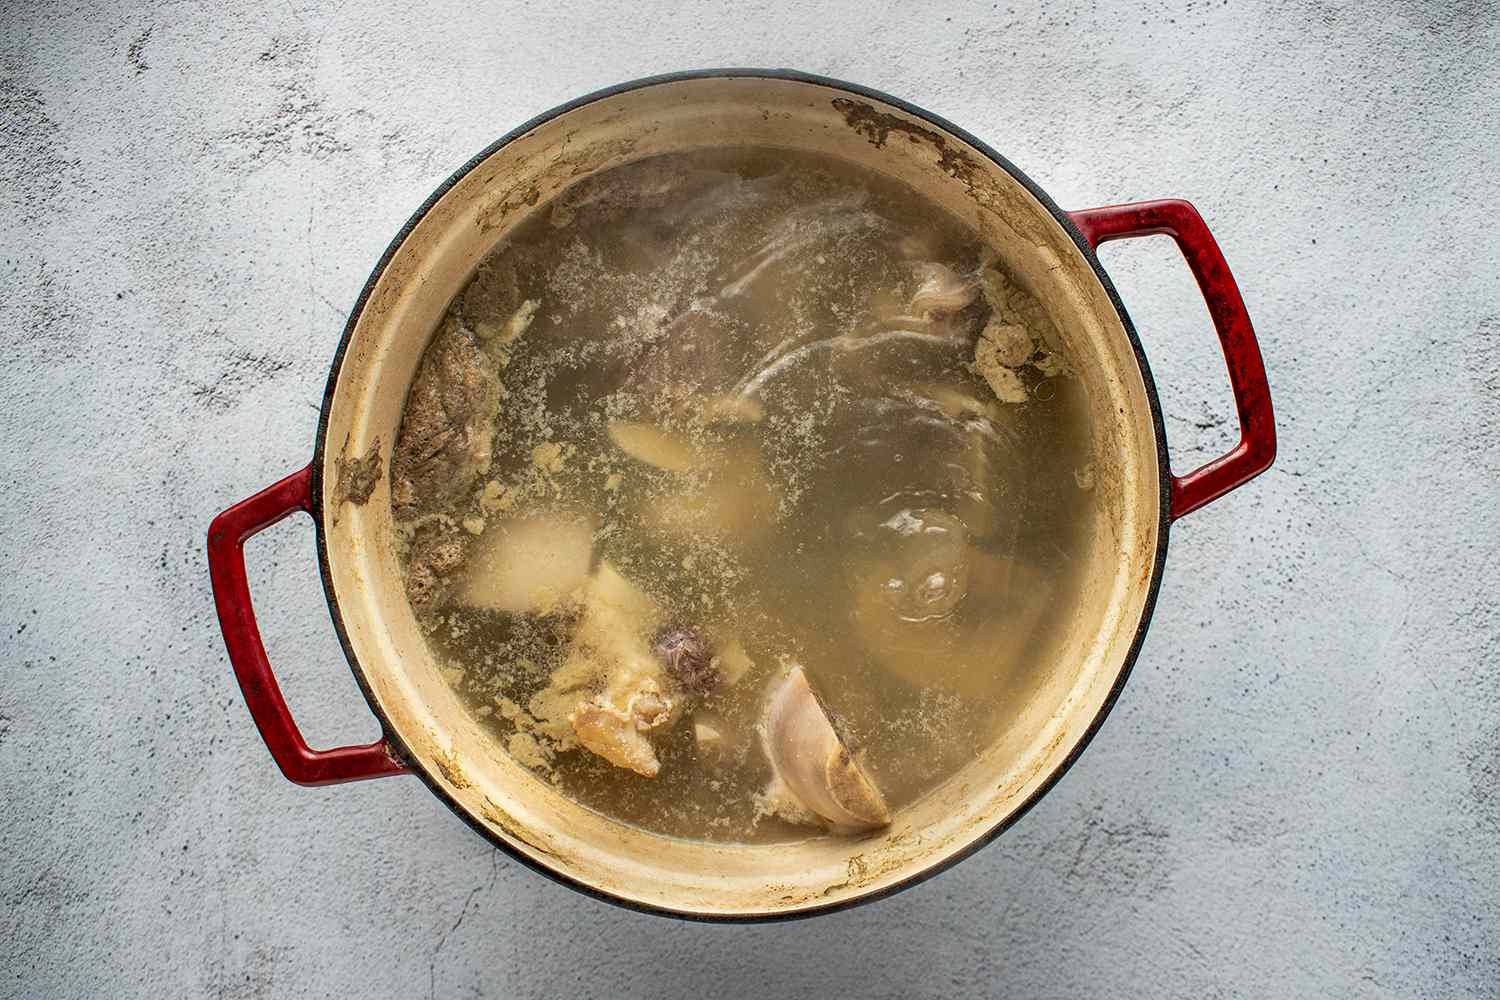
[{"x1": 1068, "y1": 198, "x2": 1277, "y2": 520}]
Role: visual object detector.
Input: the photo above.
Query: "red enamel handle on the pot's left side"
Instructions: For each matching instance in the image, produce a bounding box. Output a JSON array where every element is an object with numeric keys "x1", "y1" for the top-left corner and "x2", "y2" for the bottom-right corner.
[{"x1": 209, "y1": 465, "x2": 407, "y2": 784}]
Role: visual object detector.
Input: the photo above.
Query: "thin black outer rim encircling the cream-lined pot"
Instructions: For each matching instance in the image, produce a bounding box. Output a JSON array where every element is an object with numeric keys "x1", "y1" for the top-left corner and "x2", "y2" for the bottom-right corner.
[{"x1": 312, "y1": 67, "x2": 1172, "y2": 924}]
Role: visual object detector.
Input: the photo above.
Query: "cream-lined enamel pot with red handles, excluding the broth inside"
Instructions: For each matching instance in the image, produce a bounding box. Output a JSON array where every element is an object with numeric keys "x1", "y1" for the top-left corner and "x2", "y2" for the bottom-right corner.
[{"x1": 209, "y1": 70, "x2": 1275, "y2": 919}]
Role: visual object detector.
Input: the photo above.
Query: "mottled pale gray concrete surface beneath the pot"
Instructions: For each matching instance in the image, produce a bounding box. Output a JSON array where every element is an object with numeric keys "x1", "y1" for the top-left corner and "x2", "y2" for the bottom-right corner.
[{"x1": 0, "y1": 0, "x2": 1500, "y2": 999}]
